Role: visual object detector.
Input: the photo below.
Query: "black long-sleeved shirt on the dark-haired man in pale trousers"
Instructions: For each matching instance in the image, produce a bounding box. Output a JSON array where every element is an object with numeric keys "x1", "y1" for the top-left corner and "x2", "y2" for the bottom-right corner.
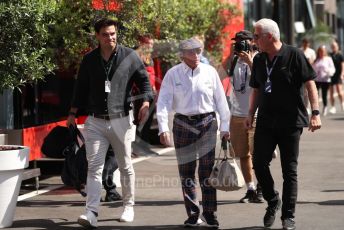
[{"x1": 72, "y1": 45, "x2": 152, "y2": 114}]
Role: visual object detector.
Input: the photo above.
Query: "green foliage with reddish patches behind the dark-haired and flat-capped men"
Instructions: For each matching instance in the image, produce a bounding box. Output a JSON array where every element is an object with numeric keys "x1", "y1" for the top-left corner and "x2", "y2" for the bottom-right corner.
[{"x1": 55, "y1": 0, "x2": 240, "y2": 69}]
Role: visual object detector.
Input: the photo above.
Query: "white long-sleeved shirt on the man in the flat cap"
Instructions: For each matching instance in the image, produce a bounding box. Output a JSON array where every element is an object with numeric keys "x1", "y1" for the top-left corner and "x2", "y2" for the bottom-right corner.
[{"x1": 156, "y1": 62, "x2": 230, "y2": 135}]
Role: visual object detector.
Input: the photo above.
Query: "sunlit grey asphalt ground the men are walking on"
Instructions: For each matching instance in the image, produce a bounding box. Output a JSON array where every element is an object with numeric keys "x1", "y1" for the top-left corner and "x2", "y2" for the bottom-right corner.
[{"x1": 4, "y1": 108, "x2": 344, "y2": 230}]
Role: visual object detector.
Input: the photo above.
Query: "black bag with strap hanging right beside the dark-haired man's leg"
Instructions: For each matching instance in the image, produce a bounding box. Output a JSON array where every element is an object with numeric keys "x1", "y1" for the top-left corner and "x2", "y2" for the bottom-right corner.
[{"x1": 61, "y1": 126, "x2": 88, "y2": 197}]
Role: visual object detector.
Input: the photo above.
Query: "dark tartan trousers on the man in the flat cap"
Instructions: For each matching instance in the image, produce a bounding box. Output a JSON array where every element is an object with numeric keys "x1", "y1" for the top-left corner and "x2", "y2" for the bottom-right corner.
[{"x1": 173, "y1": 115, "x2": 218, "y2": 217}]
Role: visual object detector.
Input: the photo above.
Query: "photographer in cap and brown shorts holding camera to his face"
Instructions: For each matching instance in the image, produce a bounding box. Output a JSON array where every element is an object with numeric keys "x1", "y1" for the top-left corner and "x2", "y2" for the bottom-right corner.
[{"x1": 230, "y1": 30, "x2": 263, "y2": 203}]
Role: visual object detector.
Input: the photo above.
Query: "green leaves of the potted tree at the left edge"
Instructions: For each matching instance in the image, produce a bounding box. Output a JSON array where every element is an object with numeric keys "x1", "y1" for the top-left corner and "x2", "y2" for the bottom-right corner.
[{"x1": 0, "y1": 0, "x2": 56, "y2": 92}]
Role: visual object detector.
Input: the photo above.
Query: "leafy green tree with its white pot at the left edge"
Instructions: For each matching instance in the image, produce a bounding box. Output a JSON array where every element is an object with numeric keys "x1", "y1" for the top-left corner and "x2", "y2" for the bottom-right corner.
[{"x1": 0, "y1": 0, "x2": 56, "y2": 228}]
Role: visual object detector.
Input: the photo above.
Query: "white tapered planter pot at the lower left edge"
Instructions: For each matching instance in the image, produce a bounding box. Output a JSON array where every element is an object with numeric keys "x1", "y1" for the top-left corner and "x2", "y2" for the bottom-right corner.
[{"x1": 0, "y1": 146, "x2": 30, "y2": 228}]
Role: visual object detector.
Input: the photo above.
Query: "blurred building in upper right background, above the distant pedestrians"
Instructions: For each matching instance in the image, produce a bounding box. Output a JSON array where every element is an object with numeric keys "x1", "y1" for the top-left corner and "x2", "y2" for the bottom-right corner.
[{"x1": 244, "y1": 0, "x2": 344, "y2": 46}]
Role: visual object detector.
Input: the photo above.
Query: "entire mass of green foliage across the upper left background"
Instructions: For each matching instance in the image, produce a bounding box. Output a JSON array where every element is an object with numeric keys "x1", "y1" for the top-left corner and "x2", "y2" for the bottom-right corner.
[{"x1": 0, "y1": 0, "x2": 240, "y2": 91}]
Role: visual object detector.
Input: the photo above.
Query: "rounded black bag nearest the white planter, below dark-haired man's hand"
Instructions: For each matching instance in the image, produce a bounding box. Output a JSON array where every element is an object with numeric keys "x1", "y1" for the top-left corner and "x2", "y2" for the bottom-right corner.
[{"x1": 41, "y1": 126, "x2": 73, "y2": 158}]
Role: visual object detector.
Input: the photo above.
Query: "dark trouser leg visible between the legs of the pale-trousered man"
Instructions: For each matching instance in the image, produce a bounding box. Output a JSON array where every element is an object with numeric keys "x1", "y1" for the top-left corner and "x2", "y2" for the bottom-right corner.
[{"x1": 102, "y1": 146, "x2": 118, "y2": 193}]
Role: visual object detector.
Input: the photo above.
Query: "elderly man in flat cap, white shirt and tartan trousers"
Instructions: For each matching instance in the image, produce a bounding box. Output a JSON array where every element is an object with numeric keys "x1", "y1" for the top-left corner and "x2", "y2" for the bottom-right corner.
[{"x1": 157, "y1": 38, "x2": 230, "y2": 228}]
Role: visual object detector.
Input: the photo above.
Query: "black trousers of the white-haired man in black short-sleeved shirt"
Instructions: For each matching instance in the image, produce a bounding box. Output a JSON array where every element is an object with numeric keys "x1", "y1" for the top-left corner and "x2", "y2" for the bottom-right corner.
[{"x1": 253, "y1": 127, "x2": 303, "y2": 219}]
